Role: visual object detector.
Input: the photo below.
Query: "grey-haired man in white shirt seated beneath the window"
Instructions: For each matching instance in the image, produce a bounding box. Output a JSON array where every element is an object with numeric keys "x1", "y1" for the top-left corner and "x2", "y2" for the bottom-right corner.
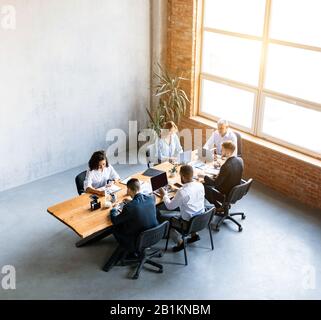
[{"x1": 203, "y1": 119, "x2": 237, "y2": 156}]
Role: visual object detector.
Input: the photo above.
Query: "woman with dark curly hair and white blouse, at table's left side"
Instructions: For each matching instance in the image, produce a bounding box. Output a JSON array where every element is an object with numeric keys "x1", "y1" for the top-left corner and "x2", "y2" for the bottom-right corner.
[{"x1": 84, "y1": 150, "x2": 119, "y2": 196}]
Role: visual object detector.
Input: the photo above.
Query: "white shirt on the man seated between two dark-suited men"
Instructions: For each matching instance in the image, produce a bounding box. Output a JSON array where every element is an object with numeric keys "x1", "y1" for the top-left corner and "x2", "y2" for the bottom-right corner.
[{"x1": 163, "y1": 181, "x2": 205, "y2": 221}]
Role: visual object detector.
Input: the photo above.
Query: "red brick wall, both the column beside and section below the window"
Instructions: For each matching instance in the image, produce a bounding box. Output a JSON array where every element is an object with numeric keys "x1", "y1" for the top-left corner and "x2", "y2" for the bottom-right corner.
[{"x1": 167, "y1": 0, "x2": 321, "y2": 209}]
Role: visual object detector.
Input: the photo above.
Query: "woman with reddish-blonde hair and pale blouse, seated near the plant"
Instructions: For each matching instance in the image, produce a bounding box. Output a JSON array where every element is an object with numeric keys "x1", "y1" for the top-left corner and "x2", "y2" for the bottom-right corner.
[{"x1": 158, "y1": 121, "x2": 183, "y2": 162}]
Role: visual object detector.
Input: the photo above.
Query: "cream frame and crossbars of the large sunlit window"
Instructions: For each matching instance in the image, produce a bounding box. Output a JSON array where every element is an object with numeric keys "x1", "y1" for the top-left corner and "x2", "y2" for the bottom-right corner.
[{"x1": 194, "y1": 0, "x2": 321, "y2": 159}]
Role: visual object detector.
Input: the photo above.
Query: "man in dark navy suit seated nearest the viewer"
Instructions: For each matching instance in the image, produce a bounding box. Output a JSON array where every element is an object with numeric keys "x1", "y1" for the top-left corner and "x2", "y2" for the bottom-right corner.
[{"x1": 103, "y1": 179, "x2": 158, "y2": 271}]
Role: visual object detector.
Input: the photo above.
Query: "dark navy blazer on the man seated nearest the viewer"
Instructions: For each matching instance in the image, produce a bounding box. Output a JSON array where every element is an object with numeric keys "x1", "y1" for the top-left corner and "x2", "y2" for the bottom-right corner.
[{"x1": 111, "y1": 193, "x2": 158, "y2": 252}]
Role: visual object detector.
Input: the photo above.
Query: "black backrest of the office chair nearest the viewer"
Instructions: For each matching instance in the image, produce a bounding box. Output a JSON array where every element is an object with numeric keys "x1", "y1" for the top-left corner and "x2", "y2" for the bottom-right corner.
[{"x1": 136, "y1": 221, "x2": 169, "y2": 252}]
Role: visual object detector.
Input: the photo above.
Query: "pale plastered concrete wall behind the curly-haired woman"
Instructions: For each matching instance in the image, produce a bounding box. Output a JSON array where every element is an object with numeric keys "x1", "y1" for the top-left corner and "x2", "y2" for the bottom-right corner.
[{"x1": 0, "y1": 0, "x2": 150, "y2": 191}]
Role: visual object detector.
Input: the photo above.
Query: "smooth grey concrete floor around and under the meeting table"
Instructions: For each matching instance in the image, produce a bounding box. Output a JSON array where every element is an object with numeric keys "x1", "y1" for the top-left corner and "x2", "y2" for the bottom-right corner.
[{"x1": 0, "y1": 165, "x2": 321, "y2": 299}]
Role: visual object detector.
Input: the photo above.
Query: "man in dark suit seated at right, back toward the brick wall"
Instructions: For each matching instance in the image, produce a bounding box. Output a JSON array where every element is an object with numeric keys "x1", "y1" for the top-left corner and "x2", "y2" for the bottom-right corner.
[{"x1": 204, "y1": 141, "x2": 244, "y2": 208}]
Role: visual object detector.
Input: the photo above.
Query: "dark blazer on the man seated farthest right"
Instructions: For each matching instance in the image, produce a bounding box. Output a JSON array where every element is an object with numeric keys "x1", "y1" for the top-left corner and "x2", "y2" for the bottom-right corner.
[{"x1": 204, "y1": 157, "x2": 244, "y2": 195}]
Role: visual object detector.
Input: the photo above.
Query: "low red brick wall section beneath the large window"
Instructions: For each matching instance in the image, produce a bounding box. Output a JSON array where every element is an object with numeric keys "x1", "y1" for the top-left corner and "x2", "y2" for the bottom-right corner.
[{"x1": 180, "y1": 118, "x2": 321, "y2": 209}]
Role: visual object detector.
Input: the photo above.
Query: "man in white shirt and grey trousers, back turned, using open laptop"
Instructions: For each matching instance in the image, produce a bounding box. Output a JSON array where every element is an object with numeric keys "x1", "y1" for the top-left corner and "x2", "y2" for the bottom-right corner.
[{"x1": 159, "y1": 165, "x2": 205, "y2": 252}]
